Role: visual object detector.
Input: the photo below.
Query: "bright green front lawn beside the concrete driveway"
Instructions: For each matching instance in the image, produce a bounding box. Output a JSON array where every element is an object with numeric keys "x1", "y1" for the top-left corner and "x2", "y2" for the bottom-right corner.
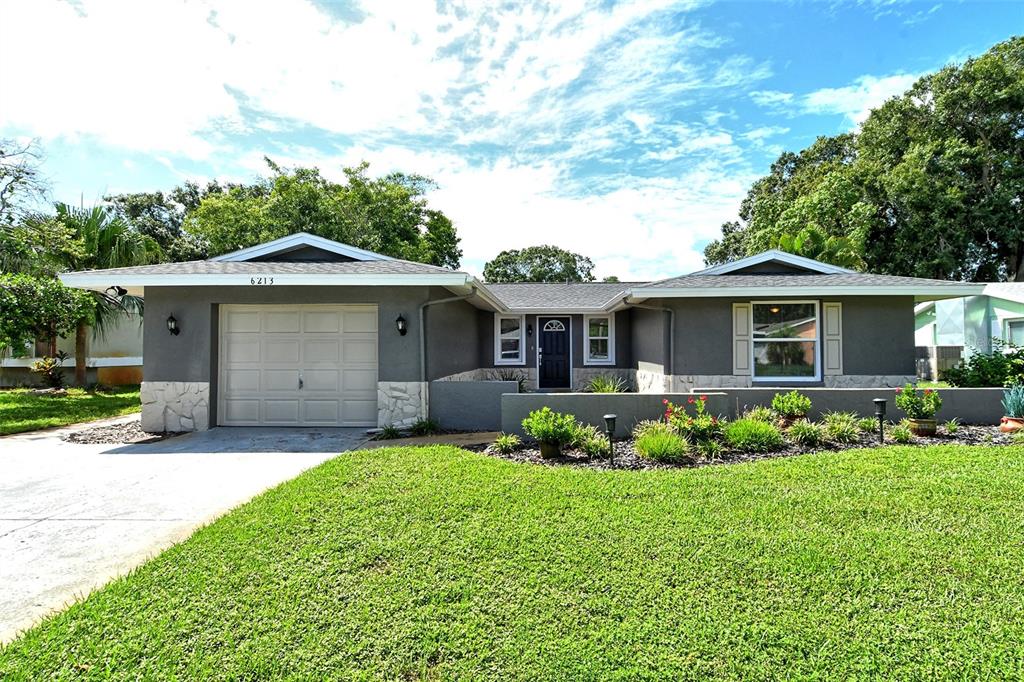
[{"x1": 0, "y1": 440, "x2": 1024, "y2": 680}]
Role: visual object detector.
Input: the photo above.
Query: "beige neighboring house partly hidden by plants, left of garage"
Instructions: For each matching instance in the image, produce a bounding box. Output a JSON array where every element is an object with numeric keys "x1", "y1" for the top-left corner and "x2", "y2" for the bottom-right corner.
[{"x1": 0, "y1": 315, "x2": 142, "y2": 387}]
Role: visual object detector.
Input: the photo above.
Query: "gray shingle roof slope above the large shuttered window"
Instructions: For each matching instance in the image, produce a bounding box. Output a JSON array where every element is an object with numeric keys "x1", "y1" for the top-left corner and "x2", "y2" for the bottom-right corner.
[{"x1": 643, "y1": 272, "x2": 965, "y2": 289}]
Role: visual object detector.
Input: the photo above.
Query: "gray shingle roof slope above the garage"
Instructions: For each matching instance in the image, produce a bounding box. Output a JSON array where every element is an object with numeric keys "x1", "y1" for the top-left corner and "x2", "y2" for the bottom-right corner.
[{"x1": 65, "y1": 260, "x2": 454, "y2": 276}]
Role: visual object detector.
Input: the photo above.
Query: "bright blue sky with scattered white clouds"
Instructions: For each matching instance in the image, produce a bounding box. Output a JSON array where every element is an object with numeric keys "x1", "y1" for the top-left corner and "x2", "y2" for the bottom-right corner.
[{"x1": 0, "y1": 0, "x2": 1024, "y2": 279}]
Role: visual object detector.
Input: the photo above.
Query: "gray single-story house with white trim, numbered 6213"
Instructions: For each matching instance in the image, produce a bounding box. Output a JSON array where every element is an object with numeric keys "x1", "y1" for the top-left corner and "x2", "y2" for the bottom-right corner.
[{"x1": 61, "y1": 233, "x2": 981, "y2": 431}]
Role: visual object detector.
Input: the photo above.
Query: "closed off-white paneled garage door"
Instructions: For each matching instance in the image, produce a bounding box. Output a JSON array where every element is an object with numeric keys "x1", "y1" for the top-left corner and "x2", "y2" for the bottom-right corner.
[{"x1": 217, "y1": 305, "x2": 377, "y2": 426}]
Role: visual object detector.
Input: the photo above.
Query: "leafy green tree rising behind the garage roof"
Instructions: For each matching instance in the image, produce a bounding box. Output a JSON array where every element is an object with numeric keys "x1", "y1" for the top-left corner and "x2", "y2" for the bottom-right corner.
[{"x1": 184, "y1": 159, "x2": 462, "y2": 267}]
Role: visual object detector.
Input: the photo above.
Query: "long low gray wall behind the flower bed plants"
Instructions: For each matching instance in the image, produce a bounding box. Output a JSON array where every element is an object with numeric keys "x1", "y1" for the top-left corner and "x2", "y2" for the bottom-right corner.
[{"x1": 501, "y1": 388, "x2": 1002, "y2": 436}]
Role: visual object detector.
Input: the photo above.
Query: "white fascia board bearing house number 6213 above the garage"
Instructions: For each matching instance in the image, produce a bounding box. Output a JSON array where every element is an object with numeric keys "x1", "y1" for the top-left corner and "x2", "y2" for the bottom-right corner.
[{"x1": 60, "y1": 270, "x2": 475, "y2": 291}]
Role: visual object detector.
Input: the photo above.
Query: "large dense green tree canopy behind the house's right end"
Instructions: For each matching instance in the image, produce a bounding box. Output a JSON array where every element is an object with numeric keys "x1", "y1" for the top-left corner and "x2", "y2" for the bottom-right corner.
[{"x1": 705, "y1": 38, "x2": 1024, "y2": 281}]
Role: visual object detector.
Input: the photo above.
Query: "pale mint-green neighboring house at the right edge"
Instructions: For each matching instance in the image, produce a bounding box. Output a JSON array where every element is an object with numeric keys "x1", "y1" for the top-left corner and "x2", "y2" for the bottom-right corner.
[{"x1": 914, "y1": 282, "x2": 1024, "y2": 379}]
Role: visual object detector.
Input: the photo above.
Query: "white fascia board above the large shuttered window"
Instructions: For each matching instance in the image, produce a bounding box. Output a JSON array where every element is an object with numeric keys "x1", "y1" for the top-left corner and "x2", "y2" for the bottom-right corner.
[{"x1": 628, "y1": 284, "x2": 983, "y2": 301}]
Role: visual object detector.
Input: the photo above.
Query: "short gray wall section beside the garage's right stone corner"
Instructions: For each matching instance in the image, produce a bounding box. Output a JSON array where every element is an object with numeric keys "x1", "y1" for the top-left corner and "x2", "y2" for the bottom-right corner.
[{"x1": 429, "y1": 381, "x2": 519, "y2": 431}]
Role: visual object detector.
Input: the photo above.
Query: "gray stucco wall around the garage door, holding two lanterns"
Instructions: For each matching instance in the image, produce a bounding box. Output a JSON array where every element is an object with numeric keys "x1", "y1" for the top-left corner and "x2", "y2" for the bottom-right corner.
[{"x1": 143, "y1": 287, "x2": 476, "y2": 383}]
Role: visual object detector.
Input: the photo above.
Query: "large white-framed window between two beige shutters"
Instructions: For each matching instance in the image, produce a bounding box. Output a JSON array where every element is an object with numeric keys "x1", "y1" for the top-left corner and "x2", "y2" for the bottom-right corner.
[{"x1": 751, "y1": 301, "x2": 821, "y2": 381}]
